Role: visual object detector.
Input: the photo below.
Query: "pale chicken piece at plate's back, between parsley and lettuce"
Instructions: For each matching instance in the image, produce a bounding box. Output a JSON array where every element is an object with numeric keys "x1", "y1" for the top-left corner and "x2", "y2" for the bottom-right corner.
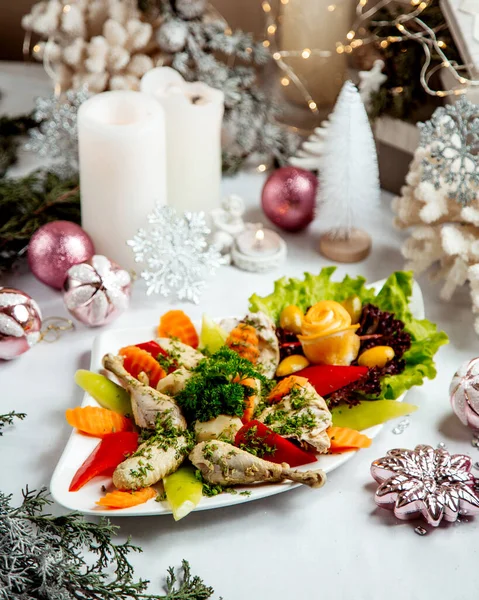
[{"x1": 220, "y1": 311, "x2": 279, "y2": 379}]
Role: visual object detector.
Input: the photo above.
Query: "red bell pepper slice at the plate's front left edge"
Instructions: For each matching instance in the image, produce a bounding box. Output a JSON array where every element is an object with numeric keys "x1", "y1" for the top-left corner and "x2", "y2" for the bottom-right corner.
[{"x1": 69, "y1": 431, "x2": 138, "y2": 492}]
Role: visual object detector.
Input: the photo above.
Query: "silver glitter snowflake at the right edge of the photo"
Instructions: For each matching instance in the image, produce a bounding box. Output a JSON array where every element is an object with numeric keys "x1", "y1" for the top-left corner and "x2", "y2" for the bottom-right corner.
[{"x1": 418, "y1": 96, "x2": 479, "y2": 205}]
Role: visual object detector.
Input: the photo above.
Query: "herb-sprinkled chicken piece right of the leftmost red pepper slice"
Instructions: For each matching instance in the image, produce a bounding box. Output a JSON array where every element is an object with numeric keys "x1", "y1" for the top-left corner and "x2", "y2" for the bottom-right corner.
[{"x1": 113, "y1": 435, "x2": 187, "y2": 490}]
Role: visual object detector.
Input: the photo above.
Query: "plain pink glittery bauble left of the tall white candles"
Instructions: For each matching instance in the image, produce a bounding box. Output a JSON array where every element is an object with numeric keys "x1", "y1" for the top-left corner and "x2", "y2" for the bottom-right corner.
[{"x1": 28, "y1": 221, "x2": 95, "y2": 290}]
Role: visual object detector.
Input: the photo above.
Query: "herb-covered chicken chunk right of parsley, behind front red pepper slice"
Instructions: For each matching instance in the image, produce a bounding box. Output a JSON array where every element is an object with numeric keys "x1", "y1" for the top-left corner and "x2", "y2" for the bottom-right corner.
[{"x1": 258, "y1": 382, "x2": 332, "y2": 453}]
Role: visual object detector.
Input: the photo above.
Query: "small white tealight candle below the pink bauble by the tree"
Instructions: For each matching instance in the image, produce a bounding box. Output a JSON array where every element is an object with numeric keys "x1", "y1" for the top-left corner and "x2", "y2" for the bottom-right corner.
[{"x1": 231, "y1": 225, "x2": 286, "y2": 272}]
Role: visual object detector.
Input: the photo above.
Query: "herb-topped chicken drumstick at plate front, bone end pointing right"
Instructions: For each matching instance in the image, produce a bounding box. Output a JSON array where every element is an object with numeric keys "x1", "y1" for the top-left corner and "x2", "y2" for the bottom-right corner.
[{"x1": 189, "y1": 440, "x2": 326, "y2": 487}]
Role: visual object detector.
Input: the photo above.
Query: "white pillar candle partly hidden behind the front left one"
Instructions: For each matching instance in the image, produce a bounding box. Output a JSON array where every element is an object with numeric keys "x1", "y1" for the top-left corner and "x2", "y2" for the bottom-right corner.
[{"x1": 141, "y1": 67, "x2": 224, "y2": 213}]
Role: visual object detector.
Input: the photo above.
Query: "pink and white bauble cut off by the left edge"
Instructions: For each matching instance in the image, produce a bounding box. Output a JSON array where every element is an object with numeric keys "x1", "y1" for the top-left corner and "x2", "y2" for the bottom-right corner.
[{"x1": 0, "y1": 287, "x2": 42, "y2": 360}]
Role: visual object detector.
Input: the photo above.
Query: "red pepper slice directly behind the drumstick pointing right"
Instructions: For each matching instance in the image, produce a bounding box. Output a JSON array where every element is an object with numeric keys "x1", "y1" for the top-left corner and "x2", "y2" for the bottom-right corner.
[{"x1": 235, "y1": 420, "x2": 317, "y2": 467}]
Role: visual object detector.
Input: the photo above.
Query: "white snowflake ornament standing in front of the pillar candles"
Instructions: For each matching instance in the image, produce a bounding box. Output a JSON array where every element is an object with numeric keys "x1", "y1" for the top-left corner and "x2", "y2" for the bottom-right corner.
[{"x1": 127, "y1": 206, "x2": 222, "y2": 304}]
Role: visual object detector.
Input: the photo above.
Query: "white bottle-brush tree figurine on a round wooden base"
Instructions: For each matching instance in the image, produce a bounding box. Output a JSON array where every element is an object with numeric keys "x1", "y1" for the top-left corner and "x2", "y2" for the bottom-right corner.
[{"x1": 318, "y1": 81, "x2": 379, "y2": 262}]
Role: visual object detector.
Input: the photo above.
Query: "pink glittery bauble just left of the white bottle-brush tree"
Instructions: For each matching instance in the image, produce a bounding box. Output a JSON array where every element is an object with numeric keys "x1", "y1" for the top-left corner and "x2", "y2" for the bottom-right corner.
[{"x1": 261, "y1": 167, "x2": 318, "y2": 231}]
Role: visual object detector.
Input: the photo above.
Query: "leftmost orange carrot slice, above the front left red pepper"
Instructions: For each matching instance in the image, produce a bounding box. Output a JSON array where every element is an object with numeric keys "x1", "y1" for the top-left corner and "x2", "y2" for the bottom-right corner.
[{"x1": 65, "y1": 406, "x2": 133, "y2": 438}]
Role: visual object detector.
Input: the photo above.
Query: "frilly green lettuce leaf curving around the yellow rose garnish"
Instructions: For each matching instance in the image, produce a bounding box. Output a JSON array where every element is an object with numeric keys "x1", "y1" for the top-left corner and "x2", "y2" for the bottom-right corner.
[{"x1": 249, "y1": 267, "x2": 448, "y2": 400}]
